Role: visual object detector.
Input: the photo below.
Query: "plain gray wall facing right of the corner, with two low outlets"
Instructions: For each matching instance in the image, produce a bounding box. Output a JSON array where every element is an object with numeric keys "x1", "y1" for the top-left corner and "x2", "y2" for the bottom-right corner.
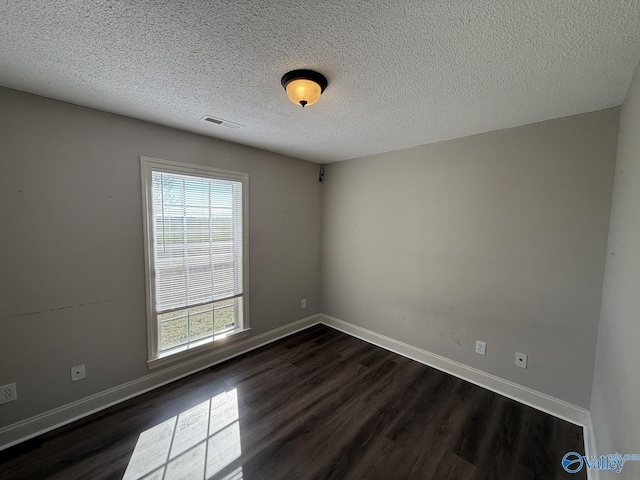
[{"x1": 321, "y1": 109, "x2": 619, "y2": 407}]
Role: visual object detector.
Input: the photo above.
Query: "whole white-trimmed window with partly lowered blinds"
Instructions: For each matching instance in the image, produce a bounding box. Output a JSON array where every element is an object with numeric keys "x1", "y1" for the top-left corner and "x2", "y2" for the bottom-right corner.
[{"x1": 140, "y1": 157, "x2": 249, "y2": 366}]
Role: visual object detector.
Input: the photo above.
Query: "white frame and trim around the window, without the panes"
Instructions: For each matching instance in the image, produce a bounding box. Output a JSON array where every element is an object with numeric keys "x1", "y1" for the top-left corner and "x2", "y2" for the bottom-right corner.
[{"x1": 140, "y1": 156, "x2": 251, "y2": 369}]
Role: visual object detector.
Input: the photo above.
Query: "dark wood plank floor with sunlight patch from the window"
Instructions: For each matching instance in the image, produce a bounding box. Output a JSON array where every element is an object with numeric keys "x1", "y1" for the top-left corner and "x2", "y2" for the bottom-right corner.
[{"x1": 0, "y1": 325, "x2": 586, "y2": 480}]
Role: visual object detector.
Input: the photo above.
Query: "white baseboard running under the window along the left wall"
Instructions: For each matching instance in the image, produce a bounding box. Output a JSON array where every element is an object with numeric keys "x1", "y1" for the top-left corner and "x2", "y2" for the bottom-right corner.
[{"x1": 0, "y1": 315, "x2": 320, "y2": 450}]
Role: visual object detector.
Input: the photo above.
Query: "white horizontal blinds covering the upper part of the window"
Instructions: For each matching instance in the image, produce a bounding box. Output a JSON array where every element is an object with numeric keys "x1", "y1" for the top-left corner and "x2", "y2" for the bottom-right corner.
[{"x1": 152, "y1": 171, "x2": 243, "y2": 314}]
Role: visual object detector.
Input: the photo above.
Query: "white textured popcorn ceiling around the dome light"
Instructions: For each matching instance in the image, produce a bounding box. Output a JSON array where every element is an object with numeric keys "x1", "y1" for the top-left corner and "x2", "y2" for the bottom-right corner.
[{"x1": 0, "y1": 0, "x2": 640, "y2": 163}]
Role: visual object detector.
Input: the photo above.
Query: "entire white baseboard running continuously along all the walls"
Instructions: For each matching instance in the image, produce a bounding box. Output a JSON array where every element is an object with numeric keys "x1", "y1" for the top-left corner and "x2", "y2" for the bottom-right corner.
[{"x1": 0, "y1": 314, "x2": 598, "y2": 470}]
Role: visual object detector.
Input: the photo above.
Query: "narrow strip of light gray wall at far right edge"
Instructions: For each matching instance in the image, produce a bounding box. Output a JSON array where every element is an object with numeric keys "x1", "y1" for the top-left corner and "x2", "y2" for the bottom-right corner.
[{"x1": 591, "y1": 62, "x2": 640, "y2": 479}]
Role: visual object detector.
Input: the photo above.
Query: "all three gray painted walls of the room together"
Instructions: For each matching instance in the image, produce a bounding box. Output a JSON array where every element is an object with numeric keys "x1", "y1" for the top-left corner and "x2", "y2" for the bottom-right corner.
[{"x1": 0, "y1": 81, "x2": 640, "y2": 438}]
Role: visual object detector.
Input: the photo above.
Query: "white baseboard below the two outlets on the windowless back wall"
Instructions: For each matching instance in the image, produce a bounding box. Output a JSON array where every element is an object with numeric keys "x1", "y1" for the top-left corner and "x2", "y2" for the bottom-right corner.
[{"x1": 320, "y1": 314, "x2": 589, "y2": 427}]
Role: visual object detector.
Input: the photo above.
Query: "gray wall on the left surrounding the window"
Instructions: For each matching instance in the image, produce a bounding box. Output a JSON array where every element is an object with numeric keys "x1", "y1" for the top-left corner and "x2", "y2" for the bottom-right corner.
[{"x1": 0, "y1": 89, "x2": 321, "y2": 427}]
